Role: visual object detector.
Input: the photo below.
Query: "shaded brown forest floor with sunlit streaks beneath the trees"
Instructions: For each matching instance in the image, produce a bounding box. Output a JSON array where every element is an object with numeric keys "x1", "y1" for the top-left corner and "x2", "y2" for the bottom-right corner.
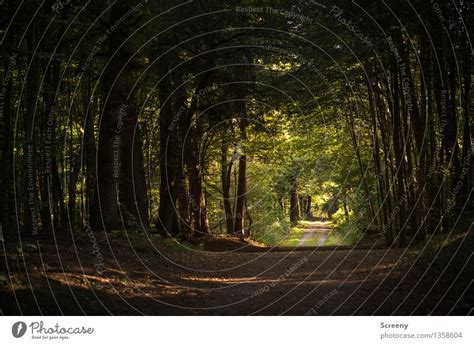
[{"x1": 0, "y1": 224, "x2": 474, "y2": 315}]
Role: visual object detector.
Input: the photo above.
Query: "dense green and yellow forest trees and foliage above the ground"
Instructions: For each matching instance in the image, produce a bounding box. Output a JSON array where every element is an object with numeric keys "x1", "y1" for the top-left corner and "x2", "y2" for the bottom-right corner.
[{"x1": 0, "y1": 0, "x2": 473, "y2": 246}]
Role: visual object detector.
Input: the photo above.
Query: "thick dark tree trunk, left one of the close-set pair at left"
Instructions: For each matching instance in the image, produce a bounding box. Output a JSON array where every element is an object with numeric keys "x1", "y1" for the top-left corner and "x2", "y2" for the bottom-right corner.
[{"x1": 90, "y1": 2, "x2": 140, "y2": 231}]
